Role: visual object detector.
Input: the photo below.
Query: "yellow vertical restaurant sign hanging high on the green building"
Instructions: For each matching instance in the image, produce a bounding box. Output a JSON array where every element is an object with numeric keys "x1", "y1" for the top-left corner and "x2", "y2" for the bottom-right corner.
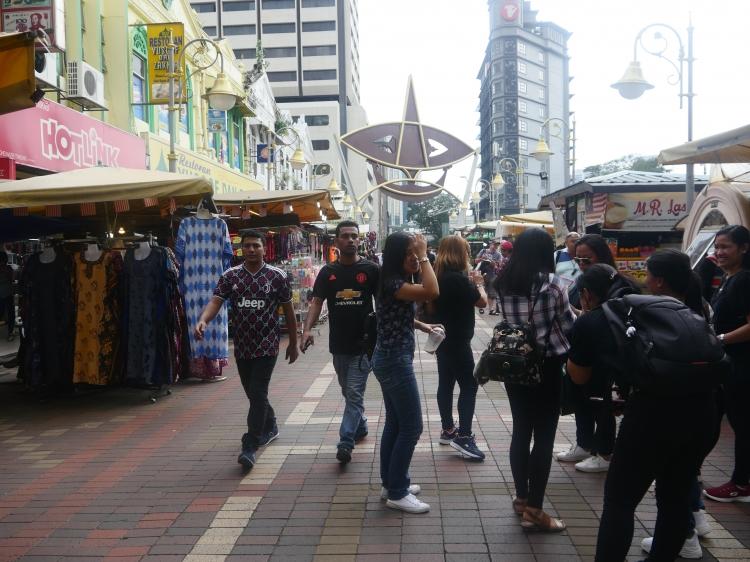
[{"x1": 146, "y1": 23, "x2": 187, "y2": 104}]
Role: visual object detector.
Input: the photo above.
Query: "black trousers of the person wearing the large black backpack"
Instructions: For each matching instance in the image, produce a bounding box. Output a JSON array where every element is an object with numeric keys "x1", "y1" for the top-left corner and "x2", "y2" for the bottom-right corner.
[{"x1": 595, "y1": 393, "x2": 716, "y2": 562}]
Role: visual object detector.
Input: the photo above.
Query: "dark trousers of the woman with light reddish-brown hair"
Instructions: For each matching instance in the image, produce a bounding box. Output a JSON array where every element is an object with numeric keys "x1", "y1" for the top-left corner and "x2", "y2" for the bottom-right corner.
[{"x1": 436, "y1": 341, "x2": 479, "y2": 435}]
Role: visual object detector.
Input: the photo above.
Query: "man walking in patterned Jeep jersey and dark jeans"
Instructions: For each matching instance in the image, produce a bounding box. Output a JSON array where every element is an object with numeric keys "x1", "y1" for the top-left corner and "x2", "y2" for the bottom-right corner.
[{"x1": 195, "y1": 230, "x2": 298, "y2": 470}]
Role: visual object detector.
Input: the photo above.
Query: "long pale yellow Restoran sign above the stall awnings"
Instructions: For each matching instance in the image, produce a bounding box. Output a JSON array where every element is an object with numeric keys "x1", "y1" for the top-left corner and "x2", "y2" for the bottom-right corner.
[{"x1": 145, "y1": 134, "x2": 263, "y2": 194}]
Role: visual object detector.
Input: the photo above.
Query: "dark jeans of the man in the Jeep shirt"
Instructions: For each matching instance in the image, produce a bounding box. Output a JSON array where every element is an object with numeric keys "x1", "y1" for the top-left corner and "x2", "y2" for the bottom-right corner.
[{"x1": 237, "y1": 355, "x2": 276, "y2": 448}]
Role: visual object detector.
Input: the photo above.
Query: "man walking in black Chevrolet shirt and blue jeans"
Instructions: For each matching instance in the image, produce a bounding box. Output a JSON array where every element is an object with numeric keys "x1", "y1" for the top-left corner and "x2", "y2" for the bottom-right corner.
[{"x1": 300, "y1": 221, "x2": 379, "y2": 464}]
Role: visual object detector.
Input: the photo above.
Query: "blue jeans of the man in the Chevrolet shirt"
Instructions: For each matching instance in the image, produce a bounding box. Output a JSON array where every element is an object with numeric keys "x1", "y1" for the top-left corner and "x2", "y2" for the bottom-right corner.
[{"x1": 333, "y1": 355, "x2": 370, "y2": 449}]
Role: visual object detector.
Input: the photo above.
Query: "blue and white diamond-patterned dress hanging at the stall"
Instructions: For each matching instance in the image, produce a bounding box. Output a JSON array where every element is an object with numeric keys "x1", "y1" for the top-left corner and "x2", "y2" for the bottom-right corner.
[{"x1": 175, "y1": 217, "x2": 232, "y2": 379}]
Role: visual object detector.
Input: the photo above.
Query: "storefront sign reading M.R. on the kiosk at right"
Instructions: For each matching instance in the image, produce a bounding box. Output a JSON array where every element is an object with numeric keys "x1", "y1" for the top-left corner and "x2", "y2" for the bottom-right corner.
[{"x1": 602, "y1": 192, "x2": 688, "y2": 232}]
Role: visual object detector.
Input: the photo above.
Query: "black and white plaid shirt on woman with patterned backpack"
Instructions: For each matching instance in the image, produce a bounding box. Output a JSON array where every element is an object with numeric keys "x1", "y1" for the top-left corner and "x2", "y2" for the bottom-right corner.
[{"x1": 498, "y1": 274, "x2": 575, "y2": 357}]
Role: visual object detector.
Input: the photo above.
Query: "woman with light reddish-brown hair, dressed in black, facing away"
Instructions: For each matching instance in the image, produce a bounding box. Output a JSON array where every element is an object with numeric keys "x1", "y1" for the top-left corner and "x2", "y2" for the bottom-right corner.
[{"x1": 434, "y1": 236, "x2": 487, "y2": 461}]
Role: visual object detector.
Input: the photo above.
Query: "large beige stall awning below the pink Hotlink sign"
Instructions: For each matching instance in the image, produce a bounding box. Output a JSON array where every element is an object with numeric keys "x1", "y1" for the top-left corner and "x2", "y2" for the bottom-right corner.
[{"x1": 0, "y1": 167, "x2": 212, "y2": 214}]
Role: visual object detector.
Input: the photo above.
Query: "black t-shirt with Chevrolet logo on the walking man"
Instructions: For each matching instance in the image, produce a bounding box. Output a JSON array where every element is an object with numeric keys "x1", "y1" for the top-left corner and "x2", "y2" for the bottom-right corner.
[{"x1": 313, "y1": 259, "x2": 380, "y2": 355}]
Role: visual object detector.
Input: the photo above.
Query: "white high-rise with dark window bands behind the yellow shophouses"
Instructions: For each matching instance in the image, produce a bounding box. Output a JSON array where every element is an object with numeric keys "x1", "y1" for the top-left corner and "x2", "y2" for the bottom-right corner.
[{"x1": 191, "y1": 0, "x2": 366, "y2": 192}]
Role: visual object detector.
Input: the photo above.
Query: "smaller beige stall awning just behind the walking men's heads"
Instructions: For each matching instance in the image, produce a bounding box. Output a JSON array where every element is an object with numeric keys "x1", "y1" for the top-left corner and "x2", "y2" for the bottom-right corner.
[{"x1": 214, "y1": 189, "x2": 341, "y2": 222}]
